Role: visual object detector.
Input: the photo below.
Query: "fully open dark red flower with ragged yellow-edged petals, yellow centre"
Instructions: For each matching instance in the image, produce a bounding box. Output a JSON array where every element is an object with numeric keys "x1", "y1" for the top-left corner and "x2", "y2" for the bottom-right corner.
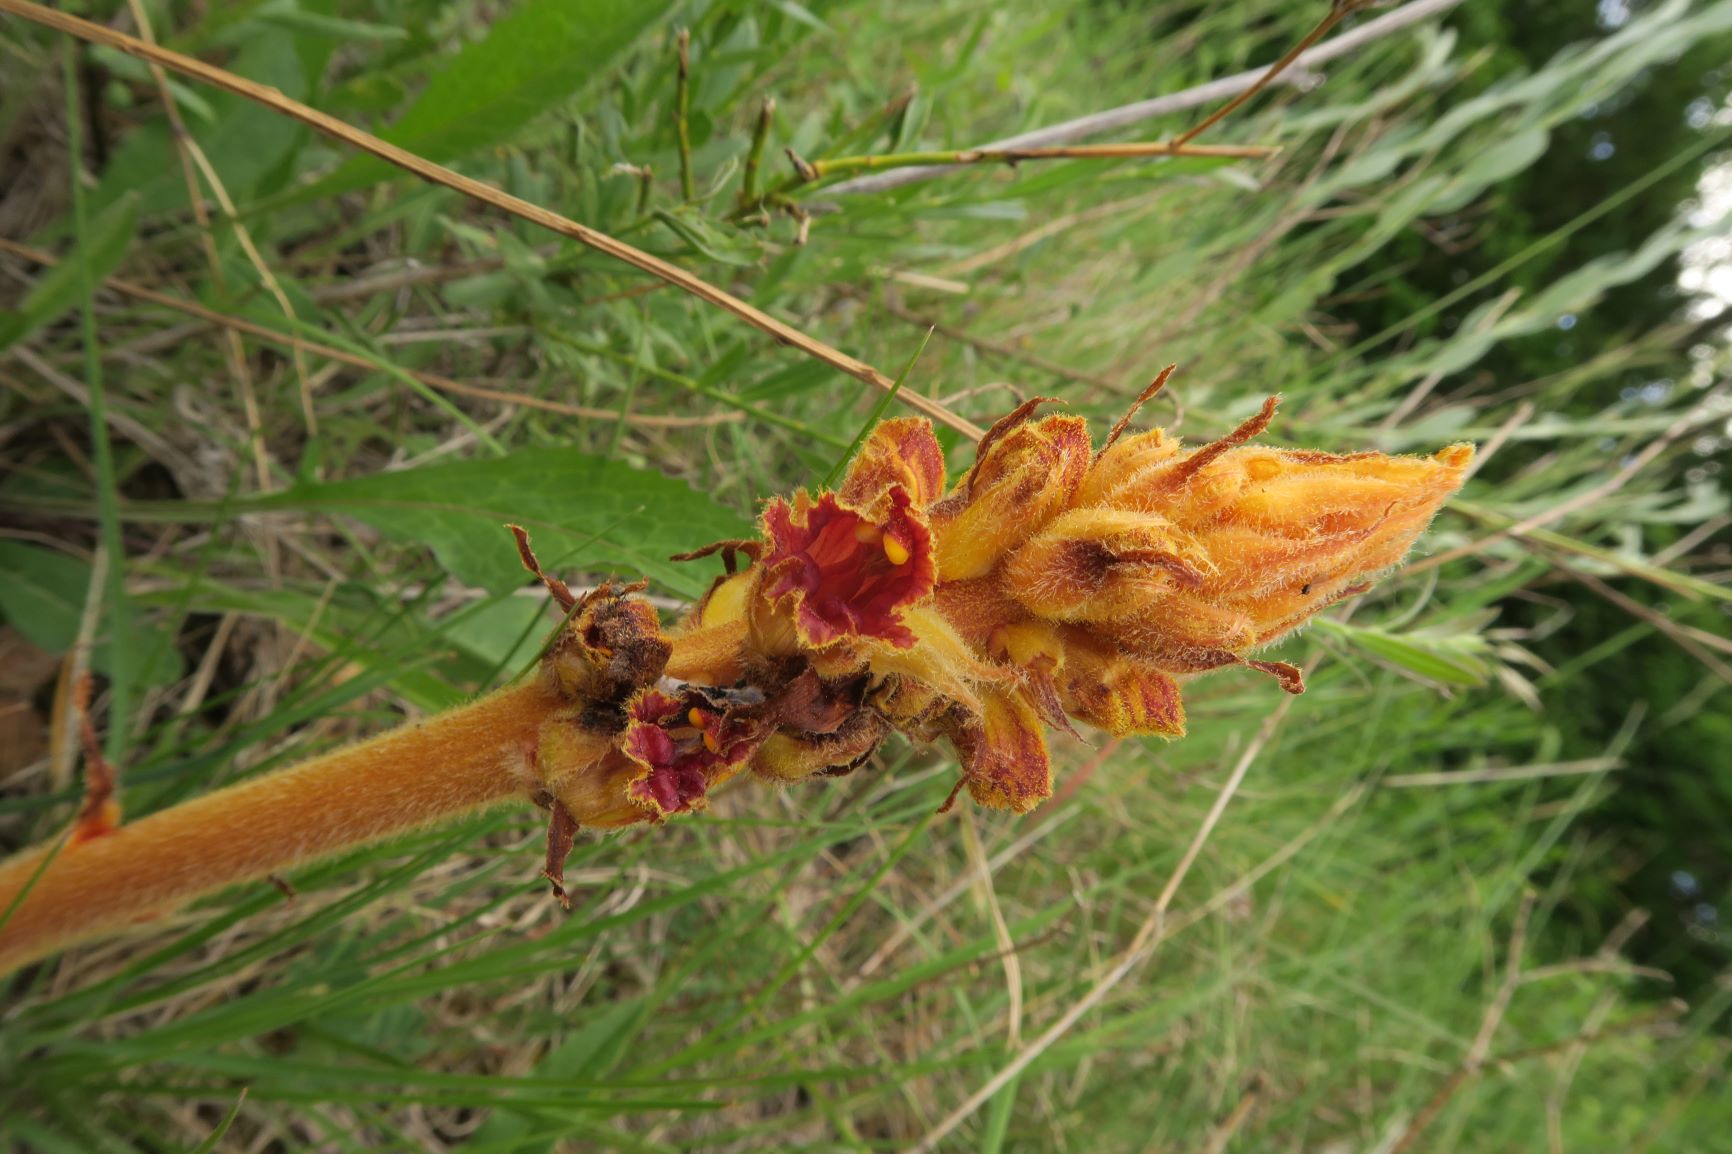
[{"x1": 762, "y1": 485, "x2": 937, "y2": 648}]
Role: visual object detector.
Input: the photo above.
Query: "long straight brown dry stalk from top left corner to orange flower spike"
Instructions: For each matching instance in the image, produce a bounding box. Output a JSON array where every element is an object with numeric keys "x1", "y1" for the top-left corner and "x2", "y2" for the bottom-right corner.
[{"x1": 0, "y1": 0, "x2": 986, "y2": 440}]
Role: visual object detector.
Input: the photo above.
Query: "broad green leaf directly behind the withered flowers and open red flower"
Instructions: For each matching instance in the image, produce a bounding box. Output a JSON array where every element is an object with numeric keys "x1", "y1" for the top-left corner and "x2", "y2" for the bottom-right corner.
[{"x1": 249, "y1": 449, "x2": 752, "y2": 596}]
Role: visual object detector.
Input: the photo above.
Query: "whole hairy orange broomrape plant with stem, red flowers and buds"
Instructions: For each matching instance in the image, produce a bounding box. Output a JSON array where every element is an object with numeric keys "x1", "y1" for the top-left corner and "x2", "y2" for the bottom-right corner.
[{"x1": 0, "y1": 374, "x2": 1472, "y2": 972}]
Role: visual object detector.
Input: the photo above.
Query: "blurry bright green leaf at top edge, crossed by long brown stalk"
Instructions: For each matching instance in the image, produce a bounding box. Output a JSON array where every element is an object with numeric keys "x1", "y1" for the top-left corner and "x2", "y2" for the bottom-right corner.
[{"x1": 307, "y1": 0, "x2": 670, "y2": 196}]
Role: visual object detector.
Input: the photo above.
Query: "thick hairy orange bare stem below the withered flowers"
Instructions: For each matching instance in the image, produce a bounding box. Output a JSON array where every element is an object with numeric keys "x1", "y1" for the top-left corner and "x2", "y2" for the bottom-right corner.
[{"x1": 0, "y1": 677, "x2": 563, "y2": 974}]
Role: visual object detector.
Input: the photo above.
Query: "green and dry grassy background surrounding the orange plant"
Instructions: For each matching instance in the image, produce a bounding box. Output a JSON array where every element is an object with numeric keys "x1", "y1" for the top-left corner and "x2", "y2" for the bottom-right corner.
[{"x1": 0, "y1": 0, "x2": 1732, "y2": 1151}]
